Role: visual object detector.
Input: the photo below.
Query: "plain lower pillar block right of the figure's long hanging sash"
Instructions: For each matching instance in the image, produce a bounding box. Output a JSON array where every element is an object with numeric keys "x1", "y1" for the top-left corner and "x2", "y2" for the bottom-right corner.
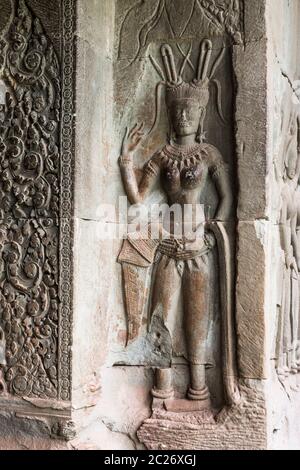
[{"x1": 236, "y1": 221, "x2": 269, "y2": 379}]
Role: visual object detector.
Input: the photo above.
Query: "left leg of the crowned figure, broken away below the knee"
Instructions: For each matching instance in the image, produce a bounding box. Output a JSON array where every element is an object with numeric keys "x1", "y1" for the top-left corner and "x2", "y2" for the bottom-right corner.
[{"x1": 151, "y1": 256, "x2": 181, "y2": 399}]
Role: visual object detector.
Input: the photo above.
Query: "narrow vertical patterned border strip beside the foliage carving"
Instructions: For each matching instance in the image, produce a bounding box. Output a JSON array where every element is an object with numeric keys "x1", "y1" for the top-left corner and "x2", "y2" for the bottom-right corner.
[{"x1": 58, "y1": 0, "x2": 76, "y2": 400}]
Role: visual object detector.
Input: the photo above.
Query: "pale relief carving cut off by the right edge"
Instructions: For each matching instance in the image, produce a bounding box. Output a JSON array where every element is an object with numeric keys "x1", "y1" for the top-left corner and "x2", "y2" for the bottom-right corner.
[{"x1": 276, "y1": 110, "x2": 300, "y2": 380}]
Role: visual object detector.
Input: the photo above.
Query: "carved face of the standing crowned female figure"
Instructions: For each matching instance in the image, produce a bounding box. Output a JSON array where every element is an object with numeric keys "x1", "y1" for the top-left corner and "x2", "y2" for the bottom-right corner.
[{"x1": 170, "y1": 99, "x2": 203, "y2": 137}]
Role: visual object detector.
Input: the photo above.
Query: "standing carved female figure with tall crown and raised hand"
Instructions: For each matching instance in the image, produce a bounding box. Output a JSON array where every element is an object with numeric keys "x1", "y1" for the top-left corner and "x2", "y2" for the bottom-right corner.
[{"x1": 119, "y1": 40, "x2": 239, "y2": 412}]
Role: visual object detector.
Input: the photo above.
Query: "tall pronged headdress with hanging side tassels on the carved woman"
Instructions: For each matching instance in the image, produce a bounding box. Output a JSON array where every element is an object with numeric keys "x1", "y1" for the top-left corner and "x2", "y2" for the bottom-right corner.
[{"x1": 150, "y1": 39, "x2": 225, "y2": 139}]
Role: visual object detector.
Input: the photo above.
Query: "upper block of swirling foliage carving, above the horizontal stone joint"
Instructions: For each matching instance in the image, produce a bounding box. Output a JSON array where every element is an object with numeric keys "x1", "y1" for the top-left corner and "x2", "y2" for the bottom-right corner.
[{"x1": 0, "y1": 2, "x2": 60, "y2": 220}]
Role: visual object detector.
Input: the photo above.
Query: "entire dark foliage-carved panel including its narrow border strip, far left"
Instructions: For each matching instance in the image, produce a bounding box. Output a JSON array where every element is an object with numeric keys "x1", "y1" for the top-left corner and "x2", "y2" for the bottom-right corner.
[{"x1": 0, "y1": 0, "x2": 74, "y2": 400}]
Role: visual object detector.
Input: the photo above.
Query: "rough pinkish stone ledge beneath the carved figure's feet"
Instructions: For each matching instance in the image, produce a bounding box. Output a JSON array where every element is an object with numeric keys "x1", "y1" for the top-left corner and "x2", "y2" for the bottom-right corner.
[{"x1": 138, "y1": 385, "x2": 266, "y2": 450}]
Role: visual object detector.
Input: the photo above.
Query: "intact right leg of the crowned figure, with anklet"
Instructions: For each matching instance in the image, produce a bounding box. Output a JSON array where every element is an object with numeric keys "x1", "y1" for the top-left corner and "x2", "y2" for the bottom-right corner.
[{"x1": 183, "y1": 263, "x2": 209, "y2": 400}]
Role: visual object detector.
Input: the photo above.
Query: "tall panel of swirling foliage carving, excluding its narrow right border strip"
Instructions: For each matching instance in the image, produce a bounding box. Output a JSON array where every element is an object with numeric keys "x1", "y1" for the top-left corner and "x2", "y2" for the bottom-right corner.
[{"x1": 0, "y1": 0, "x2": 60, "y2": 398}]
